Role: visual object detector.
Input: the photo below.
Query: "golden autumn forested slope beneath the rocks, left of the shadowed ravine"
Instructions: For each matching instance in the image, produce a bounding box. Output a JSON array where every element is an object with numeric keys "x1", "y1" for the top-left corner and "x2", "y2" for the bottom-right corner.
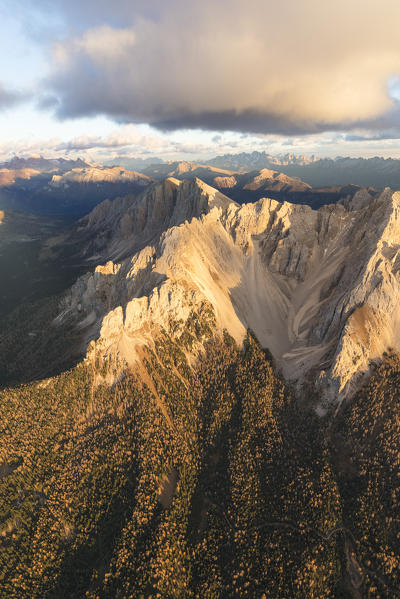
[{"x1": 0, "y1": 336, "x2": 346, "y2": 598}]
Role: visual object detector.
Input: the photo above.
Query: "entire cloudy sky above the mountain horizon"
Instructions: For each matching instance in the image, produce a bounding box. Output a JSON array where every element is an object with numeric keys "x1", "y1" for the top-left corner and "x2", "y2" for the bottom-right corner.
[{"x1": 0, "y1": 0, "x2": 400, "y2": 162}]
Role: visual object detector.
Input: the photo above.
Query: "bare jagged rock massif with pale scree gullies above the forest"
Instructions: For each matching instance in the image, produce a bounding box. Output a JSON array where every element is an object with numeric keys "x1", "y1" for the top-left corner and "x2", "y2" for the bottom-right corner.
[{"x1": 59, "y1": 179, "x2": 400, "y2": 409}]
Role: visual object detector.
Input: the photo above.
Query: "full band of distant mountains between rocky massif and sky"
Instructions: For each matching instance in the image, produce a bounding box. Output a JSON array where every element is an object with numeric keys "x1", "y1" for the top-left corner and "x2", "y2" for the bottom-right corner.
[{"x1": 0, "y1": 152, "x2": 400, "y2": 217}]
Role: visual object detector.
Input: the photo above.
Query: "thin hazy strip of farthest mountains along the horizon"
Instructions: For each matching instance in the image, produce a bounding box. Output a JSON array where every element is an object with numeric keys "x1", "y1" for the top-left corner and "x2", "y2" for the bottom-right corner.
[{"x1": 4, "y1": 151, "x2": 400, "y2": 189}]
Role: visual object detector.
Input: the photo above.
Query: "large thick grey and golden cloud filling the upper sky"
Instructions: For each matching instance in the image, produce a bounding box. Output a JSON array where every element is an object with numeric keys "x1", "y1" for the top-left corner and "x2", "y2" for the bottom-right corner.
[{"x1": 41, "y1": 0, "x2": 400, "y2": 135}]
